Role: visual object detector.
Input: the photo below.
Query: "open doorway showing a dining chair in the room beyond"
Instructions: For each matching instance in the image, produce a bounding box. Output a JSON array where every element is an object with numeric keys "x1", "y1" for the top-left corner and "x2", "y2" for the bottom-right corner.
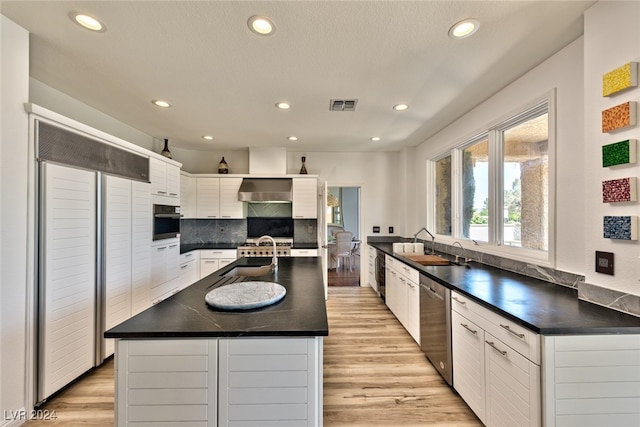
[{"x1": 325, "y1": 186, "x2": 361, "y2": 286}]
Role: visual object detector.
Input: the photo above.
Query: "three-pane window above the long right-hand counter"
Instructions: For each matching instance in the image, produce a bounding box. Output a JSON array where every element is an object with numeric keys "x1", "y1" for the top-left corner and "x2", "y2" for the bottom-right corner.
[{"x1": 431, "y1": 97, "x2": 551, "y2": 260}]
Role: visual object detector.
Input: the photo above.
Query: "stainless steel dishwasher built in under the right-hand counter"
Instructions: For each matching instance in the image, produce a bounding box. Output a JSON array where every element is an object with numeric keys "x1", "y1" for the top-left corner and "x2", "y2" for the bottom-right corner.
[{"x1": 420, "y1": 274, "x2": 453, "y2": 385}]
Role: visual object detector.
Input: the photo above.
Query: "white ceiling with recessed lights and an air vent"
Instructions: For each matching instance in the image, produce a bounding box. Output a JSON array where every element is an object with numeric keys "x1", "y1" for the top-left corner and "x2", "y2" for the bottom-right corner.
[{"x1": 0, "y1": 0, "x2": 594, "y2": 151}]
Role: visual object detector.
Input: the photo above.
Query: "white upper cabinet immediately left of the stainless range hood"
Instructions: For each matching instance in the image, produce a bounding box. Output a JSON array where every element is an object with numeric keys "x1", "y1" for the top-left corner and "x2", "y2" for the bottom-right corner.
[{"x1": 196, "y1": 177, "x2": 244, "y2": 219}]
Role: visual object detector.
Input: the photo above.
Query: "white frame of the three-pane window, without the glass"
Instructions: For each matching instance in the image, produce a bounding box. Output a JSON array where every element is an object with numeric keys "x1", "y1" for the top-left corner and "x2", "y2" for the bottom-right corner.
[{"x1": 426, "y1": 89, "x2": 556, "y2": 267}]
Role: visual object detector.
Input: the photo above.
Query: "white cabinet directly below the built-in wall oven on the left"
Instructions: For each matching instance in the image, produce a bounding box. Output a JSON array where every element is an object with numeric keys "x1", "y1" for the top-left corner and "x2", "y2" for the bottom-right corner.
[{"x1": 150, "y1": 239, "x2": 180, "y2": 304}]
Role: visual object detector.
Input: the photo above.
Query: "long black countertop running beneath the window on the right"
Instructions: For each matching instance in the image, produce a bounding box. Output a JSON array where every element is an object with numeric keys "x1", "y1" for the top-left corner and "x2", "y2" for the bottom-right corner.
[{"x1": 368, "y1": 242, "x2": 640, "y2": 335}]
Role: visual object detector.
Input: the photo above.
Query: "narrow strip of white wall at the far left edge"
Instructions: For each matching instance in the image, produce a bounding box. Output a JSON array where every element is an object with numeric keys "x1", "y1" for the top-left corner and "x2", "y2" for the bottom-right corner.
[{"x1": 0, "y1": 16, "x2": 31, "y2": 425}]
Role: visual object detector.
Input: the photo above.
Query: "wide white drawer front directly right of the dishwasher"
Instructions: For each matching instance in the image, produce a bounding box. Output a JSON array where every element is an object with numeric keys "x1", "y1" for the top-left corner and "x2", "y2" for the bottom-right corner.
[{"x1": 451, "y1": 292, "x2": 540, "y2": 365}]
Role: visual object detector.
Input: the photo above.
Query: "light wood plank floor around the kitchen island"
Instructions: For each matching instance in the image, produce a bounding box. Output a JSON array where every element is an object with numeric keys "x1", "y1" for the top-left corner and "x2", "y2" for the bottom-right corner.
[{"x1": 25, "y1": 287, "x2": 482, "y2": 427}]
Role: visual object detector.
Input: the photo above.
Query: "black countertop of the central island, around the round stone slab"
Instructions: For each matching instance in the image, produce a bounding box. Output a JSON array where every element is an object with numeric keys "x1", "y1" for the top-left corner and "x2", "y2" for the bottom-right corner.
[{"x1": 104, "y1": 257, "x2": 329, "y2": 339}]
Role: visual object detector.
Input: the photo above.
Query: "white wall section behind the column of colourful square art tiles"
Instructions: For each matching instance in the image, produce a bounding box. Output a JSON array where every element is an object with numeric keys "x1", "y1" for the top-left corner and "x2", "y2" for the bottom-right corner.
[{"x1": 582, "y1": 2, "x2": 640, "y2": 295}]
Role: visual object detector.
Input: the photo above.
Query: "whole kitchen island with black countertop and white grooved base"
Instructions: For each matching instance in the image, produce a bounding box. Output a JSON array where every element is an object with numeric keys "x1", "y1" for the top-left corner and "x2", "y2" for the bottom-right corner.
[{"x1": 105, "y1": 258, "x2": 329, "y2": 426}]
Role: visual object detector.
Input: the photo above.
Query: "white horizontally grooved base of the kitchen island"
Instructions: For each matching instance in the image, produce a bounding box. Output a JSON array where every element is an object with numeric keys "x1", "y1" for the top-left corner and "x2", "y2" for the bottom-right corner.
[{"x1": 115, "y1": 337, "x2": 322, "y2": 427}]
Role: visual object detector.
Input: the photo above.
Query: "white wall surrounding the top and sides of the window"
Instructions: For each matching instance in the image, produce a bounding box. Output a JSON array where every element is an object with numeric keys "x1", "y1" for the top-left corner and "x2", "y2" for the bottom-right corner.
[{"x1": 408, "y1": 38, "x2": 585, "y2": 274}]
